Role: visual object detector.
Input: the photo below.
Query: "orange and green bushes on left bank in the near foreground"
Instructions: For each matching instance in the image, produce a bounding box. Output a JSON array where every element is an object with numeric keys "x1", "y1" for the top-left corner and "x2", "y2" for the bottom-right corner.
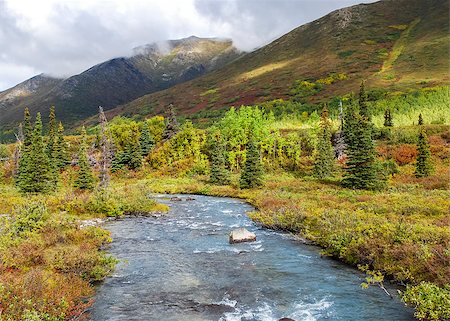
[{"x1": 0, "y1": 202, "x2": 116, "y2": 321}]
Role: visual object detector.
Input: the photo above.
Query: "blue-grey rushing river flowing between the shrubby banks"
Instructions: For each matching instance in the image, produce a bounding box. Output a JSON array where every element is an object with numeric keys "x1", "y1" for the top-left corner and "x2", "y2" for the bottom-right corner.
[{"x1": 91, "y1": 195, "x2": 414, "y2": 321}]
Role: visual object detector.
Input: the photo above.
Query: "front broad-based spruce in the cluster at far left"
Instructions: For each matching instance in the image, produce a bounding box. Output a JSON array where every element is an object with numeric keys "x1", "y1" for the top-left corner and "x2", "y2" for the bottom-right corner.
[{"x1": 19, "y1": 113, "x2": 54, "y2": 193}]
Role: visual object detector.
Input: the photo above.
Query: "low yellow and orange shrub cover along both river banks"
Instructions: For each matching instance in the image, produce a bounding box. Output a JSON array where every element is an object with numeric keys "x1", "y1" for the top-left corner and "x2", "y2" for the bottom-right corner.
[{"x1": 0, "y1": 172, "x2": 450, "y2": 321}]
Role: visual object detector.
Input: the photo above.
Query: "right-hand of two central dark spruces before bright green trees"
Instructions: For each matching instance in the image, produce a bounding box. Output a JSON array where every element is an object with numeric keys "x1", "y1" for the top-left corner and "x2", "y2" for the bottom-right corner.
[{"x1": 239, "y1": 138, "x2": 263, "y2": 188}]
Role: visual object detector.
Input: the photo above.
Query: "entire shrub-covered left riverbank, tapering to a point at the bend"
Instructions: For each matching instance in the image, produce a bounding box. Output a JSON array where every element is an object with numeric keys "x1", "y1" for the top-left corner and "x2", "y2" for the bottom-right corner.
[{"x1": 0, "y1": 184, "x2": 167, "y2": 321}]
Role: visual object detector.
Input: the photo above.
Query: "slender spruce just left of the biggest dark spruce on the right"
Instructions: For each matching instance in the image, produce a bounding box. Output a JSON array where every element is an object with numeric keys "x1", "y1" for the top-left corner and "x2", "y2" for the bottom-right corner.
[{"x1": 314, "y1": 108, "x2": 334, "y2": 179}]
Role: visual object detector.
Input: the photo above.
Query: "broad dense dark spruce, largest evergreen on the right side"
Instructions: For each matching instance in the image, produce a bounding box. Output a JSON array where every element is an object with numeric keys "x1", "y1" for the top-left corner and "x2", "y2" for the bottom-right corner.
[{"x1": 342, "y1": 102, "x2": 384, "y2": 189}]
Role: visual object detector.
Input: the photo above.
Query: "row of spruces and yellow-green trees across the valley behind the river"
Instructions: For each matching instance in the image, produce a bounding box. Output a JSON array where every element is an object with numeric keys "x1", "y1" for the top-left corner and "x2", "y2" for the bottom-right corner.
[{"x1": 15, "y1": 82, "x2": 433, "y2": 193}]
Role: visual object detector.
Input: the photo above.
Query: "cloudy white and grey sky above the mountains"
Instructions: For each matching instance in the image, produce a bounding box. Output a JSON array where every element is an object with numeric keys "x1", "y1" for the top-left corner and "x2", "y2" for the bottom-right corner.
[{"x1": 0, "y1": 0, "x2": 374, "y2": 91}]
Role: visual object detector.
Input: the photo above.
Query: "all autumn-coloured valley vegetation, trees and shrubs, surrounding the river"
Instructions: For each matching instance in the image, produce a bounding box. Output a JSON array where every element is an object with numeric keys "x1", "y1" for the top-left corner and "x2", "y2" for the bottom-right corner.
[{"x1": 0, "y1": 84, "x2": 450, "y2": 321}]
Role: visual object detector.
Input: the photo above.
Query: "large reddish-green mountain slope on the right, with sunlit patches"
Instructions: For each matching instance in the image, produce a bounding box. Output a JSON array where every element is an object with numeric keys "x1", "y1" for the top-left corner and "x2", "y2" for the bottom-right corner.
[{"x1": 103, "y1": 0, "x2": 450, "y2": 121}]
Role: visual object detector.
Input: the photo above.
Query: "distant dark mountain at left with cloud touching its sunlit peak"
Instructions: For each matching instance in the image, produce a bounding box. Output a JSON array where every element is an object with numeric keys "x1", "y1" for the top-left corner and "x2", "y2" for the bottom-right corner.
[{"x1": 0, "y1": 36, "x2": 242, "y2": 136}]
